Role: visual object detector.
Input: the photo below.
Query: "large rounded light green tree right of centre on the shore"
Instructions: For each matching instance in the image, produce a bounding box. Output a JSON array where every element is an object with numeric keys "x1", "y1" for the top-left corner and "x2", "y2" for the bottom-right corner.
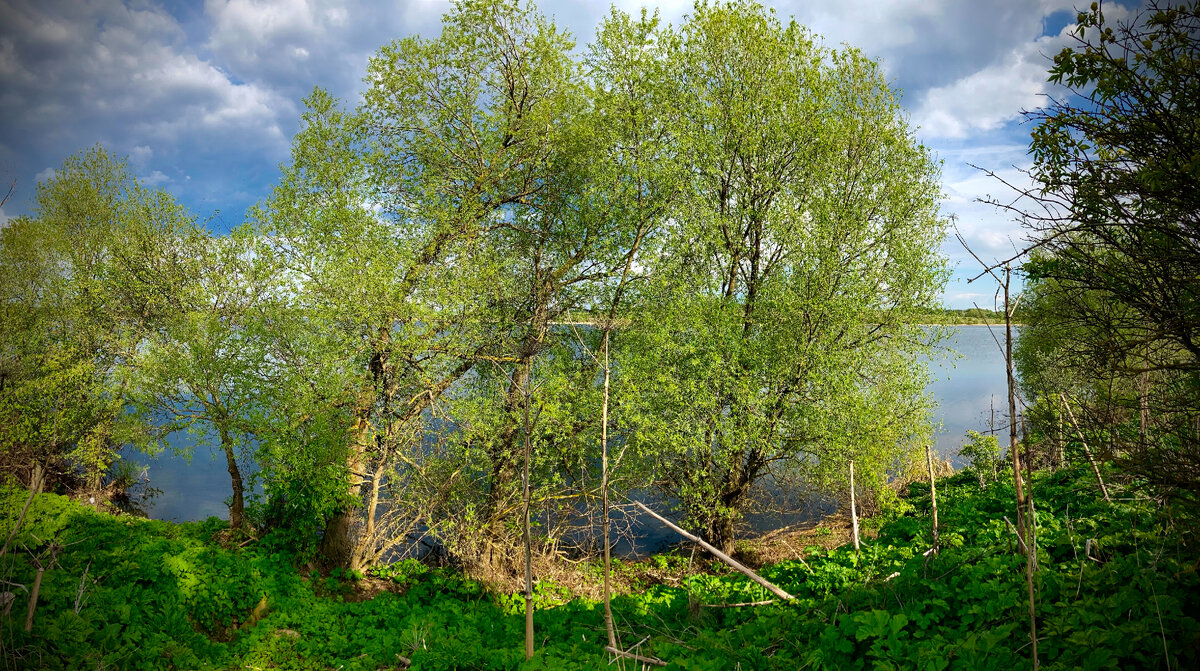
[{"x1": 618, "y1": 4, "x2": 944, "y2": 552}]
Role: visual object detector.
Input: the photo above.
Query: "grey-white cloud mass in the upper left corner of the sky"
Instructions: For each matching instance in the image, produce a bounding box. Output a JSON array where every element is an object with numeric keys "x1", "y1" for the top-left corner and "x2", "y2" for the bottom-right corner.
[{"x1": 0, "y1": 0, "x2": 296, "y2": 216}]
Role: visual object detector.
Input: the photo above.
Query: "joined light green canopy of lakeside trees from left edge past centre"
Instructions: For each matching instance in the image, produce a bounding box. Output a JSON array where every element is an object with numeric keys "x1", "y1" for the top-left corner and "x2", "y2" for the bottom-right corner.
[{"x1": 4, "y1": 0, "x2": 946, "y2": 574}]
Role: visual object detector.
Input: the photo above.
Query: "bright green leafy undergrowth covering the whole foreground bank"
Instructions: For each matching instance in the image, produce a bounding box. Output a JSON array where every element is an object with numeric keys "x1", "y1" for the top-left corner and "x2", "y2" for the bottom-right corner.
[{"x1": 0, "y1": 471, "x2": 1200, "y2": 671}]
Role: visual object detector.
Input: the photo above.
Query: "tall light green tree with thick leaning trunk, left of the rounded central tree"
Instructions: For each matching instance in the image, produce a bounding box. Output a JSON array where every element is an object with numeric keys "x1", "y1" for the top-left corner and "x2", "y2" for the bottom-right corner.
[{"x1": 257, "y1": 1, "x2": 588, "y2": 567}]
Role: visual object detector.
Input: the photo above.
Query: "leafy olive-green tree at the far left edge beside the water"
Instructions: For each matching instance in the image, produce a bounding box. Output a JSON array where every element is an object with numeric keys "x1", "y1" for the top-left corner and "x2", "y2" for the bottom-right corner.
[{"x1": 0, "y1": 146, "x2": 196, "y2": 495}]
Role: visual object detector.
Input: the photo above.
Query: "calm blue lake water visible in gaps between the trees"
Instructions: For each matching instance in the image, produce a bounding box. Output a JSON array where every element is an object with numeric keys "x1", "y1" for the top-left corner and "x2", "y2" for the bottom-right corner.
[{"x1": 134, "y1": 326, "x2": 1007, "y2": 552}]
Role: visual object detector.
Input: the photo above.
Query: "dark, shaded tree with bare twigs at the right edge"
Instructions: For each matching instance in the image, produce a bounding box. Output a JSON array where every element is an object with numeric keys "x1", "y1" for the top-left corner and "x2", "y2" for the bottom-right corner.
[{"x1": 1012, "y1": 1, "x2": 1200, "y2": 497}]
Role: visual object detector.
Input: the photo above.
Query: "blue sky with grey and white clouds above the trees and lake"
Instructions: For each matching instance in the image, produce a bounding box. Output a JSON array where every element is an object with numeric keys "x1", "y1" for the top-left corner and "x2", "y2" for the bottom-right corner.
[{"x1": 0, "y1": 0, "x2": 1142, "y2": 307}]
